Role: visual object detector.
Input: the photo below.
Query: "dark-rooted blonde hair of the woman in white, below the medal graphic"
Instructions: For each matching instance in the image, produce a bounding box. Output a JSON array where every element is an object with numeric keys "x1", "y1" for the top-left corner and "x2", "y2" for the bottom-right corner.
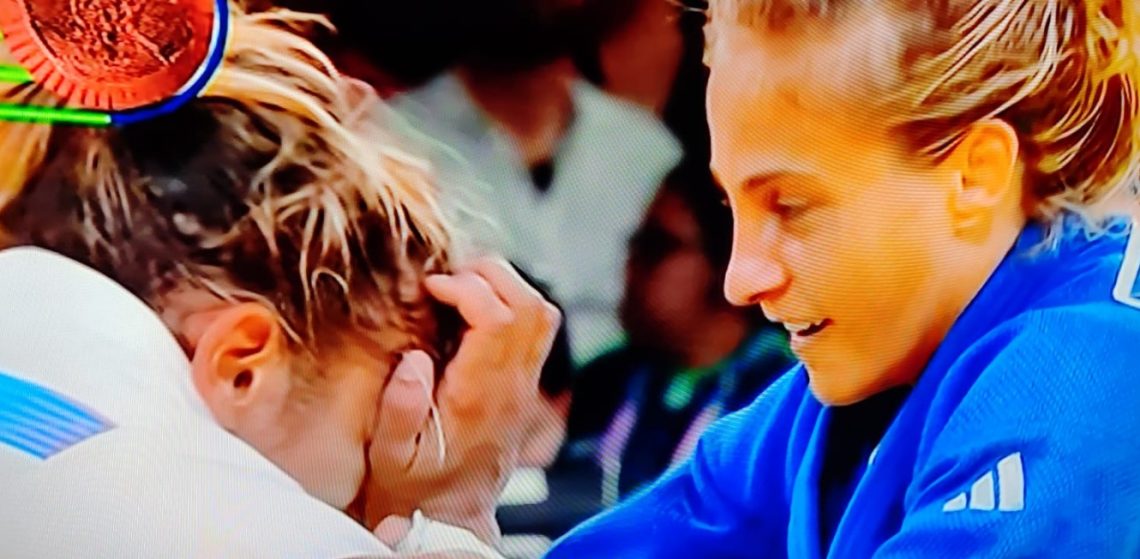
[{"x1": 0, "y1": 8, "x2": 455, "y2": 362}]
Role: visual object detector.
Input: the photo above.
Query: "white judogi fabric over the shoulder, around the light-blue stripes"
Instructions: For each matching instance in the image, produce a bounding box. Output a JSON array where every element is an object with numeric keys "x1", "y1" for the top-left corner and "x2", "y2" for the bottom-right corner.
[{"x1": 0, "y1": 249, "x2": 495, "y2": 559}]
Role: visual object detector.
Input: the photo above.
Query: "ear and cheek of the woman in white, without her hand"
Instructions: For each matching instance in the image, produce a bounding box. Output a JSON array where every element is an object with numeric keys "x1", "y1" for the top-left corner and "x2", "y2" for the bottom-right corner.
[{"x1": 186, "y1": 303, "x2": 424, "y2": 509}]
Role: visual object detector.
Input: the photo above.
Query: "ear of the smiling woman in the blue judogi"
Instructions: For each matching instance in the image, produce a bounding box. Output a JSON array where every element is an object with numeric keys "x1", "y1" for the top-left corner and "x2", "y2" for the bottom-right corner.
[{"x1": 947, "y1": 119, "x2": 1023, "y2": 230}]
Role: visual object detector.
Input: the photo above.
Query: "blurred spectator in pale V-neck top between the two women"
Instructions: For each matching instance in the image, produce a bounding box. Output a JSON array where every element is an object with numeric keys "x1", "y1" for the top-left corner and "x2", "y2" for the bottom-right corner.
[{"x1": 383, "y1": 0, "x2": 681, "y2": 363}]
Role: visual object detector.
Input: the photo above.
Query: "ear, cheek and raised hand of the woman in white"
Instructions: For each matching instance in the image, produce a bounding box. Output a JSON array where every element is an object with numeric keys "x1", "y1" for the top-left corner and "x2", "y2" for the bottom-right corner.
[{"x1": 171, "y1": 259, "x2": 561, "y2": 541}]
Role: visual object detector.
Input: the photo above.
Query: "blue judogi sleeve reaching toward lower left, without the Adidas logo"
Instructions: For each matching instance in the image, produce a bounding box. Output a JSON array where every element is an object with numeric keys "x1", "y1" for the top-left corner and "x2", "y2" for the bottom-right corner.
[{"x1": 545, "y1": 368, "x2": 806, "y2": 559}]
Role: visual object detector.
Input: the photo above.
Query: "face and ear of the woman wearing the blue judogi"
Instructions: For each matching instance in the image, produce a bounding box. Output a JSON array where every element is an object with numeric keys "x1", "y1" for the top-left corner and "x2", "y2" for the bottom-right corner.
[{"x1": 708, "y1": 14, "x2": 1026, "y2": 405}]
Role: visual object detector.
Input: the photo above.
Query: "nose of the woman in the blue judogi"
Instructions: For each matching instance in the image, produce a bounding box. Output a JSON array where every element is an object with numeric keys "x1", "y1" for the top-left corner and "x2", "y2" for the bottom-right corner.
[{"x1": 724, "y1": 220, "x2": 788, "y2": 306}]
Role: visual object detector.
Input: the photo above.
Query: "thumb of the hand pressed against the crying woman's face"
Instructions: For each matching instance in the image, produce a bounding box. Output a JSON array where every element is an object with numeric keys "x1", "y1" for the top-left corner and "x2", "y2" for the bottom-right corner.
[{"x1": 369, "y1": 350, "x2": 434, "y2": 464}]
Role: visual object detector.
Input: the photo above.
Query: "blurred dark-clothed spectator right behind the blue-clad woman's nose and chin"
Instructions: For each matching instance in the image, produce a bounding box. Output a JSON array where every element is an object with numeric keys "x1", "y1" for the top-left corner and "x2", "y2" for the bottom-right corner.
[{"x1": 559, "y1": 161, "x2": 792, "y2": 505}]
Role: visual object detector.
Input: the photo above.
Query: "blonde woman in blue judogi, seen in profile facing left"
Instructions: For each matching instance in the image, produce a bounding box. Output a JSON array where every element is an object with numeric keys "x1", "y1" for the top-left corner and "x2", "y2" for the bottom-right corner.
[{"x1": 548, "y1": 0, "x2": 1140, "y2": 559}]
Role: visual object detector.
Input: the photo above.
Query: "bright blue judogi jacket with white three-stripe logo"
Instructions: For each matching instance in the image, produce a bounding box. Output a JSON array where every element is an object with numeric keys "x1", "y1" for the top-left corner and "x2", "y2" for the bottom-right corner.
[{"x1": 546, "y1": 219, "x2": 1140, "y2": 559}]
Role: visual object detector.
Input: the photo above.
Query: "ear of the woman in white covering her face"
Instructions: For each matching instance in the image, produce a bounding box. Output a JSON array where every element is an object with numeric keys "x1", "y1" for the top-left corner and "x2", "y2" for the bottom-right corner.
[{"x1": 184, "y1": 303, "x2": 291, "y2": 432}]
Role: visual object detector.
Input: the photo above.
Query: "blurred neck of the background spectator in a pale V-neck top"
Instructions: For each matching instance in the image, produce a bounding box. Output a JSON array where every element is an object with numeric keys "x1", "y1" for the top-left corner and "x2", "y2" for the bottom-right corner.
[{"x1": 459, "y1": 59, "x2": 575, "y2": 165}]
